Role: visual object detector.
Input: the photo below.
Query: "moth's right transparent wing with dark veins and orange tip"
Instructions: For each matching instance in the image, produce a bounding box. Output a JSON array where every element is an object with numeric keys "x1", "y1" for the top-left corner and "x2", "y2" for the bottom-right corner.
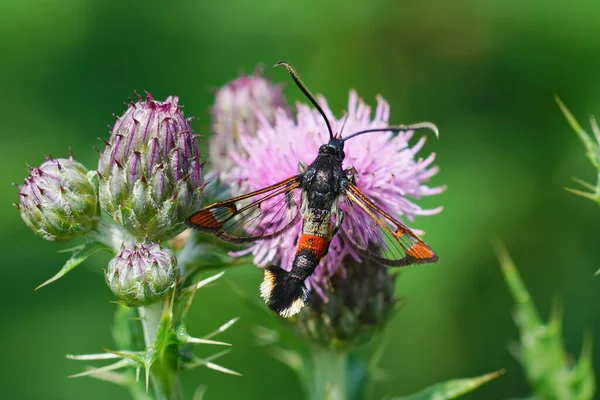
[{"x1": 340, "y1": 184, "x2": 438, "y2": 266}]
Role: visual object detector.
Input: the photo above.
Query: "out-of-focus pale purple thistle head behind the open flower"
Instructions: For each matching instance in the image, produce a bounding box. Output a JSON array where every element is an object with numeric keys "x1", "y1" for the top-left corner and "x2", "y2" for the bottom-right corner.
[{"x1": 209, "y1": 70, "x2": 287, "y2": 172}]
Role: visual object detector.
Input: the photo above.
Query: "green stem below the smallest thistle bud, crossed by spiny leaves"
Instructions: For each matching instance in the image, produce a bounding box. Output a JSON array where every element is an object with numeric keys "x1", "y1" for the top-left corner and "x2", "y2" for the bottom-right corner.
[{"x1": 139, "y1": 302, "x2": 183, "y2": 400}]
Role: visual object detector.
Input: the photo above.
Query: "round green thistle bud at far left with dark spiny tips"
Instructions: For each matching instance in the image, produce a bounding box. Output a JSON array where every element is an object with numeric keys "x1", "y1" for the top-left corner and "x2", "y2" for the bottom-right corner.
[{"x1": 16, "y1": 158, "x2": 100, "y2": 241}]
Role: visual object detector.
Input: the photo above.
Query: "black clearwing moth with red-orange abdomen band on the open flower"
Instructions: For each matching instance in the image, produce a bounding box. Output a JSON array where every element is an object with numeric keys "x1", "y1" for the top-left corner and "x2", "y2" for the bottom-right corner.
[{"x1": 186, "y1": 61, "x2": 438, "y2": 317}]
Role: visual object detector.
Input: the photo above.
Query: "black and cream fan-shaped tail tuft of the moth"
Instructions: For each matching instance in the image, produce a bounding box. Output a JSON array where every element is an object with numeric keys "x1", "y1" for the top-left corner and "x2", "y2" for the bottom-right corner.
[{"x1": 260, "y1": 265, "x2": 310, "y2": 318}]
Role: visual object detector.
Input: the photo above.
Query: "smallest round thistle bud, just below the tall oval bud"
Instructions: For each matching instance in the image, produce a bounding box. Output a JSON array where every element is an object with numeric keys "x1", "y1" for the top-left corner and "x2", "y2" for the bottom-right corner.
[{"x1": 104, "y1": 243, "x2": 179, "y2": 307}]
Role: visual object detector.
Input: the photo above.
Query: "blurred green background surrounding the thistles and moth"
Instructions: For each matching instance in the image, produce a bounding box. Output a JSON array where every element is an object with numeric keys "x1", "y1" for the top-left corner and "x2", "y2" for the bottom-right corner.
[{"x1": 0, "y1": 0, "x2": 600, "y2": 399}]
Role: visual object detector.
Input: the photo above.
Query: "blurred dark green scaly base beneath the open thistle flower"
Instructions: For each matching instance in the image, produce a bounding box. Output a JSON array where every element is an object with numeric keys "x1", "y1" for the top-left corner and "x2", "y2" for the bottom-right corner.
[{"x1": 296, "y1": 257, "x2": 398, "y2": 349}]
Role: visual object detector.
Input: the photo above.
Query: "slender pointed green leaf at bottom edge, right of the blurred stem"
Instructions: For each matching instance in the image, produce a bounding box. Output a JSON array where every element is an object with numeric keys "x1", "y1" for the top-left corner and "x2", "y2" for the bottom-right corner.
[{"x1": 392, "y1": 370, "x2": 504, "y2": 400}]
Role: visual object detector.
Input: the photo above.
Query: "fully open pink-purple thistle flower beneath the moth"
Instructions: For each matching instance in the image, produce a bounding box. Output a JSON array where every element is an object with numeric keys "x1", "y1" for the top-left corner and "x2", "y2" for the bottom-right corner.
[{"x1": 218, "y1": 91, "x2": 444, "y2": 296}]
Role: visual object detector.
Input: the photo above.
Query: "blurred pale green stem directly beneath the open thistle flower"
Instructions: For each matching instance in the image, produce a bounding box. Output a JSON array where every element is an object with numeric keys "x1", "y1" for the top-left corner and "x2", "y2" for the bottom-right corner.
[{"x1": 309, "y1": 347, "x2": 348, "y2": 400}]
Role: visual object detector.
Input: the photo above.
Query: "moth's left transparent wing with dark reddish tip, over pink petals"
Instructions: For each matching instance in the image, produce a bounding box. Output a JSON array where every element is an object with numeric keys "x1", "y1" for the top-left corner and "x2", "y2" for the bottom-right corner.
[{"x1": 186, "y1": 175, "x2": 301, "y2": 243}]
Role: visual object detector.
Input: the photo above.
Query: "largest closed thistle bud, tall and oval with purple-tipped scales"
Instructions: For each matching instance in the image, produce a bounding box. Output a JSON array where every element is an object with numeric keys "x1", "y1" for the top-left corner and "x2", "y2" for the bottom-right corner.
[{"x1": 98, "y1": 94, "x2": 204, "y2": 241}]
